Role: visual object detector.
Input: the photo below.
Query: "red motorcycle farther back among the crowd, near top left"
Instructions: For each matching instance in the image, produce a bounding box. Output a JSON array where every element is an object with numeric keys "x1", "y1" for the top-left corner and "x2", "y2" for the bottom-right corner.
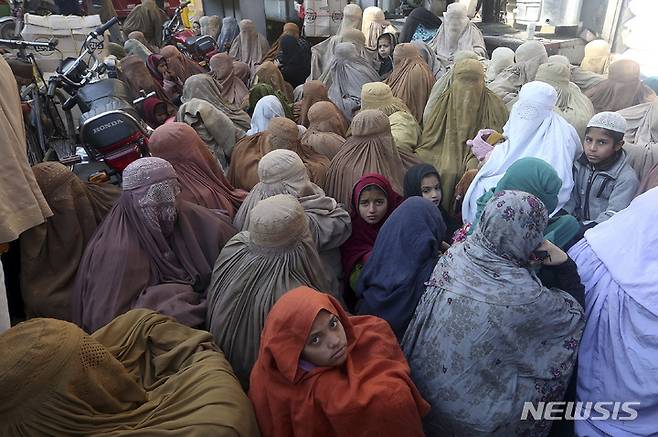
[{"x1": 162, "y1": 0, "x2": 219, "y2": 66}]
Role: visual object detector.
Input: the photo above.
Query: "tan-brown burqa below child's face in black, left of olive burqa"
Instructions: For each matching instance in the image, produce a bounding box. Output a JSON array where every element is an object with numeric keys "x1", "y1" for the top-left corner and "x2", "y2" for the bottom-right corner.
[{"x1": 385, "y1": 43, "x2": 435, "y2": 123}]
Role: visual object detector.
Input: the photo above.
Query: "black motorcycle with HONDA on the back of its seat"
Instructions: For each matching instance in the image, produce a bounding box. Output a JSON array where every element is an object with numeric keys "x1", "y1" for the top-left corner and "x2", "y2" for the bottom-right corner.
[{"x1": 48, "y1": 17, "x2": 154, "y2": 184}]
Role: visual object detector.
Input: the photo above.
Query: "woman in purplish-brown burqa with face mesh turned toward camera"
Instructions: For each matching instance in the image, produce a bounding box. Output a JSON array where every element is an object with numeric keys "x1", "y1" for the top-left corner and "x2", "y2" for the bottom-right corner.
[{"x1": 72, "y1": 158, "x2": 236, "y2": 331}]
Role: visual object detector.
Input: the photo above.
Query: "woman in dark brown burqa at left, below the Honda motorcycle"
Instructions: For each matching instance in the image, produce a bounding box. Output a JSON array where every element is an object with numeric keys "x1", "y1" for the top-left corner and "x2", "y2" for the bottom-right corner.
[{"x1": 19, "y1": 162, "x2": 121, "y2": 320}]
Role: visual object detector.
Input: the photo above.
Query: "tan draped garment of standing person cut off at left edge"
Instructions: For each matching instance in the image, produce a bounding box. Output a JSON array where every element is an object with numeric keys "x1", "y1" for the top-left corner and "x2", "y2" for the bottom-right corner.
[{"x1": 0, "y1": 57, "x2": 53, "y2": 243}]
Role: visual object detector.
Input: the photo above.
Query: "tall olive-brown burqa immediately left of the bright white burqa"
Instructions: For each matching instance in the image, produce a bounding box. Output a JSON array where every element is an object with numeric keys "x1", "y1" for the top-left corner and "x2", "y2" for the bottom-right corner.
[{"x1": 416, "y1": 59, "x2": 508, "y2": 210}]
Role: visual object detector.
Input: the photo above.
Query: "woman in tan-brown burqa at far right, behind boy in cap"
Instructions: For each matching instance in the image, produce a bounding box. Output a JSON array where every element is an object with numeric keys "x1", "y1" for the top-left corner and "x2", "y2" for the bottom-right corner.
[{"x1": 584, "y1": 59, "x2": 656, "y2": 113}]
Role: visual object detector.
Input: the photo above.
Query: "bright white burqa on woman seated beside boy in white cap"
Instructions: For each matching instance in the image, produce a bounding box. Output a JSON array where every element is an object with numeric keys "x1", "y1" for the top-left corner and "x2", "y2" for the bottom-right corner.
[{"x1": 462, "y1": 82, "x2": 580, "y2": 223}]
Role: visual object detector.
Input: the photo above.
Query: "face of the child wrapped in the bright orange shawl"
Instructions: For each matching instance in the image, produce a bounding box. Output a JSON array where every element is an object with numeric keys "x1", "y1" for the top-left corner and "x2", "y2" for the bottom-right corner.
[{"x1": 302, "y1": 310, "x2": 347, "y2": 367}]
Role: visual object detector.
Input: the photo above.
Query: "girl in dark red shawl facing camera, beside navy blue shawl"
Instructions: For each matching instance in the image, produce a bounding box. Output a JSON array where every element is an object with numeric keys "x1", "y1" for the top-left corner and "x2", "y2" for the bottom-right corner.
[{"x1": 340, "y1": 173, "x2": 404, "y2": 308}]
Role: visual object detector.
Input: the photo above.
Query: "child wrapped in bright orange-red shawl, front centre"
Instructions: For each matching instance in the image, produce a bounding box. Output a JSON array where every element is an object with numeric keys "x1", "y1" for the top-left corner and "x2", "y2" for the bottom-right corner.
[{"x1": 249, "y1": 287, "x2": 430, "y2": 437}]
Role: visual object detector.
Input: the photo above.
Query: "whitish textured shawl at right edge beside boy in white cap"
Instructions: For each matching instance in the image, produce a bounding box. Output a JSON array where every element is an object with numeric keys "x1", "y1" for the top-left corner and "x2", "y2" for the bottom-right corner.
[{"x1": 619, "y1": 100, "x2": 658, "y2": 181}]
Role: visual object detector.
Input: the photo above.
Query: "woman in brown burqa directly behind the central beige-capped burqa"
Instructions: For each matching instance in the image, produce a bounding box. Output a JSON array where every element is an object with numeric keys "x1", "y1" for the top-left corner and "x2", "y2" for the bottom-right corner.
[{"x1": 228, "y1": 117, "x2": 329, "y2": 191}]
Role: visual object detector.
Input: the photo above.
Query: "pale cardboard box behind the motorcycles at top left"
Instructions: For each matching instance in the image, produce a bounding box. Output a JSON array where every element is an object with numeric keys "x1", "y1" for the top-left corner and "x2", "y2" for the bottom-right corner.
[{"x1": 21, "y1": 14, "x2": 101, "y2": 73}]
